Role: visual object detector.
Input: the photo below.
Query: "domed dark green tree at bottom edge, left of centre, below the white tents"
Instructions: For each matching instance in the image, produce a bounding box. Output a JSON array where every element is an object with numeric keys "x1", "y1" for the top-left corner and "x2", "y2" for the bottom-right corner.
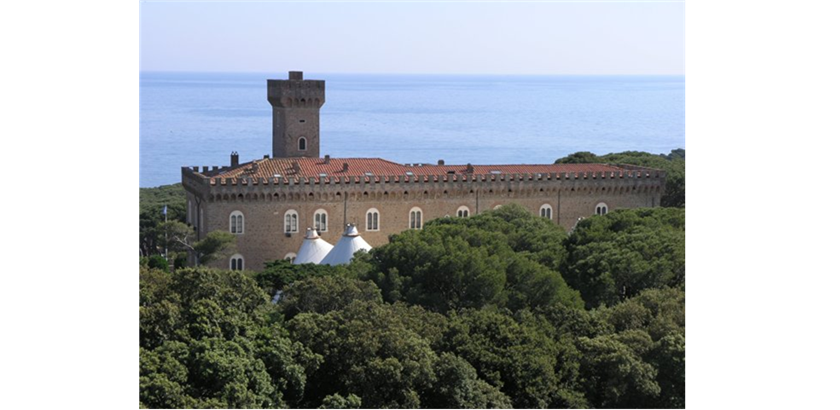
[{"x1": 289, "y1": 301, "x2": 437, "y2": 410}]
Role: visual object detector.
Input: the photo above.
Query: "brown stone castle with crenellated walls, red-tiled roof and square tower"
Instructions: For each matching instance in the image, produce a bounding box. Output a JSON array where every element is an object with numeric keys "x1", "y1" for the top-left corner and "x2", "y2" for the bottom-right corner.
[{"x1": 181, "y1": 71, "x2": 665, "y2": 270}]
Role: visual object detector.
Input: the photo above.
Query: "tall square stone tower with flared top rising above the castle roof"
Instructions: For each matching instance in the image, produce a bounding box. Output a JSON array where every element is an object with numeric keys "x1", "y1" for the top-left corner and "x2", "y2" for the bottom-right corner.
[{"x1": 268, "y1": 71, "x2": 325, "y2": 158}]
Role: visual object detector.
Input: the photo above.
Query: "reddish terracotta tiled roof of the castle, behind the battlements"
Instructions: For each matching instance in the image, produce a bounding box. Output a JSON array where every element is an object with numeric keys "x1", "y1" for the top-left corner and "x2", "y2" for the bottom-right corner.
[{"x1": 204, "y1": 158, "x2": 625, "y2": 180}]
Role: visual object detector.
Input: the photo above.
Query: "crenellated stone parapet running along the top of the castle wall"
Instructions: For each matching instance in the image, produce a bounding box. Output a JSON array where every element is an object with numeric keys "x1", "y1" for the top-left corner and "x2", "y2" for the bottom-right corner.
[{"x1": 182, "y1": 163, "x2": 666, "y2": 201}]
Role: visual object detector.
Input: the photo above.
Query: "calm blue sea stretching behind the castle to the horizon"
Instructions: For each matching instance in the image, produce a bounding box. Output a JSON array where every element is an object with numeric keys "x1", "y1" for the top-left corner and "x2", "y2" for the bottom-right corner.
[{"x1": 140, "y1": 73, "x2": 686, "y2": 187}]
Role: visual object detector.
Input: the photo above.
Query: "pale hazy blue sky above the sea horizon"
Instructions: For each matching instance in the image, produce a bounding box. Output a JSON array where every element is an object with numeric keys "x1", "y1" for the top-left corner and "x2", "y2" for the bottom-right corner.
[{"x1": 140, "y1": 1, "x2": 686, "y2": 74}]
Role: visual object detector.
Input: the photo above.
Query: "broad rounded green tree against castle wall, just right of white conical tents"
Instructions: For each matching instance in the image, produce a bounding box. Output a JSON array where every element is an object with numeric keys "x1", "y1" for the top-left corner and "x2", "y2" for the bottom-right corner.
[{"x1": 363, "y1": 206, "x2": 582, "y2": 312}]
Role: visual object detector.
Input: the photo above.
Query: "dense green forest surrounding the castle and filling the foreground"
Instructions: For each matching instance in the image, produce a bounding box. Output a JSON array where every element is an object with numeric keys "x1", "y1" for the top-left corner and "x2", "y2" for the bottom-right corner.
[{"x1": 139, "y1": 150, "x2": 686, "y2": 410}]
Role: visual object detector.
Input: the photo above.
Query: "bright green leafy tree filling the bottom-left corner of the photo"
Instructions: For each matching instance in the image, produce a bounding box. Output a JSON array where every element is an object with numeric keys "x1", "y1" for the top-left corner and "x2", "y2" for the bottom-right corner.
[{"x1": 139, "y1": 266, "x2": 320, "y2": 409}]
